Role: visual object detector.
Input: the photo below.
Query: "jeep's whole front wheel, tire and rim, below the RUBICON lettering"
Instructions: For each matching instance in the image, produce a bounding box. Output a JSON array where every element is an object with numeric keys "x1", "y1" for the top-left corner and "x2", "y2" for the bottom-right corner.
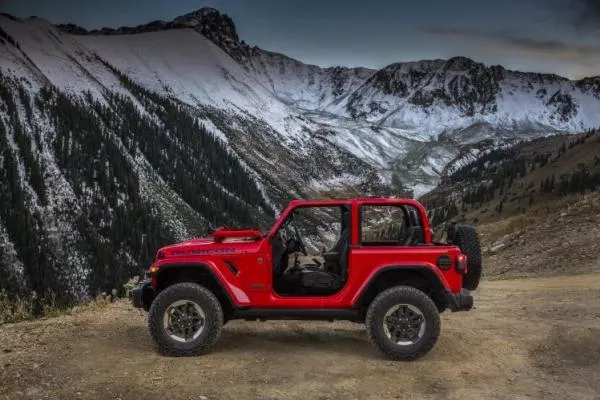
[{"x1": 148, "y1": 283, "x2": 223, "y2": 356}]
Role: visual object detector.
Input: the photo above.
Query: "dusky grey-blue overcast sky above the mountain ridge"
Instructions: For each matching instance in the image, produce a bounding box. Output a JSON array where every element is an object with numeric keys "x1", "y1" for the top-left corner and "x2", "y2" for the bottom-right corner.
[{"x1": 0, "y1": 0, "x2": 600, "y2": 78}]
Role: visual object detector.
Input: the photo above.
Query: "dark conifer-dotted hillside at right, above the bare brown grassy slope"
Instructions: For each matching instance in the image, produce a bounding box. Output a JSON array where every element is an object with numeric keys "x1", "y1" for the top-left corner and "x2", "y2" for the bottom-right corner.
[{"x1": 421, "y1": 131, "x2": 600, "y2": 225}]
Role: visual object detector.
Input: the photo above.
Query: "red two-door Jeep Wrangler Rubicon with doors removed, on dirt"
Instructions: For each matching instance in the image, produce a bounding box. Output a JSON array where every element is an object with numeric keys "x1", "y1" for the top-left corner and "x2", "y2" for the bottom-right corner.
[{"x1": 132, "y1": 198, "x2": 481, "y2": 360}]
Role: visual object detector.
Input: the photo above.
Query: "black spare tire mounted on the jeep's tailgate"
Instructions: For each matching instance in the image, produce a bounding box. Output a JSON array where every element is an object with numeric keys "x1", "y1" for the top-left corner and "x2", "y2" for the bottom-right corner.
[{"x1": 448, "y1": 225, "x2": 483, "y2": 290}]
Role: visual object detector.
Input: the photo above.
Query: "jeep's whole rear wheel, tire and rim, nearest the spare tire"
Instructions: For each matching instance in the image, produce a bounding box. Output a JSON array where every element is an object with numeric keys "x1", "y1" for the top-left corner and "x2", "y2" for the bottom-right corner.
[{"x1": 365, "y1": 286, "x2": 440, "y2": 361}]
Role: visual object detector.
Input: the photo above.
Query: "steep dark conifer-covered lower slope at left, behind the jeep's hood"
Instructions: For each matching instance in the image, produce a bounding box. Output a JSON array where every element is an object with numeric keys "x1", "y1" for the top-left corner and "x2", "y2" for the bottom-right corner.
[{"x1": 0, "y1": 65, "x2": 282, "y2": 300}]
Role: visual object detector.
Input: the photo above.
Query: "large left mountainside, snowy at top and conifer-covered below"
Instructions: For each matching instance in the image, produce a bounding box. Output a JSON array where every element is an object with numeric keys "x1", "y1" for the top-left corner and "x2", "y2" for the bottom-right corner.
[{"x1": 0, "y1": 10, "x2": 384, "y2": 302}]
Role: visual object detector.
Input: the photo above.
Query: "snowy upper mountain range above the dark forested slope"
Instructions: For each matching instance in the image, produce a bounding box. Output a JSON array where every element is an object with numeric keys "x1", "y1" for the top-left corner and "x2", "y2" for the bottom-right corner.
[{"x1": 5, "y1": 8, "x2": 600, "y2": 191}]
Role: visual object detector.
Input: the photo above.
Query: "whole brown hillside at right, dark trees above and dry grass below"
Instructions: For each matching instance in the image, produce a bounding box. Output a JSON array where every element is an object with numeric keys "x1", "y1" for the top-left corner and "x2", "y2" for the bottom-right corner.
[{"x1": 422, "y1": 131, "x2": 600, "y2": 278}]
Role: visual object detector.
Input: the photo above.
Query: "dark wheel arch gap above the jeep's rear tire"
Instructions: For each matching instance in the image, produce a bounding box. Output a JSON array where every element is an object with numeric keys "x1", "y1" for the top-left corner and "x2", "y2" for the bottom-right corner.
[{"x1": 353, "y1": 265, "x2": 448, "y2": 311}]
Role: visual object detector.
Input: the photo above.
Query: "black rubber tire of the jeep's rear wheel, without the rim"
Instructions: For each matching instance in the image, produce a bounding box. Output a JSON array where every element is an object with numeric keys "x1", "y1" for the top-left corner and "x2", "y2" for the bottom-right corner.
[{"x1": 365, "y1": 286, "x2": 441, "y2": 361}]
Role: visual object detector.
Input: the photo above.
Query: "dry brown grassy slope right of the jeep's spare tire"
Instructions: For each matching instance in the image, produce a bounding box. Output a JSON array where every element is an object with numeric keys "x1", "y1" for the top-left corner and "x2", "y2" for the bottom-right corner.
[{"x1": 478, "y1": 191, "x2": 600, "y2": 279}]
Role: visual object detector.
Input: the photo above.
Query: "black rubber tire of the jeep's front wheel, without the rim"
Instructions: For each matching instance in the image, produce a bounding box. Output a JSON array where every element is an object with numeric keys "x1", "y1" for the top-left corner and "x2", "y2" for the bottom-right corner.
[{"x1": 148, "y1": 283, "x2": 223, "y2": 357}]
